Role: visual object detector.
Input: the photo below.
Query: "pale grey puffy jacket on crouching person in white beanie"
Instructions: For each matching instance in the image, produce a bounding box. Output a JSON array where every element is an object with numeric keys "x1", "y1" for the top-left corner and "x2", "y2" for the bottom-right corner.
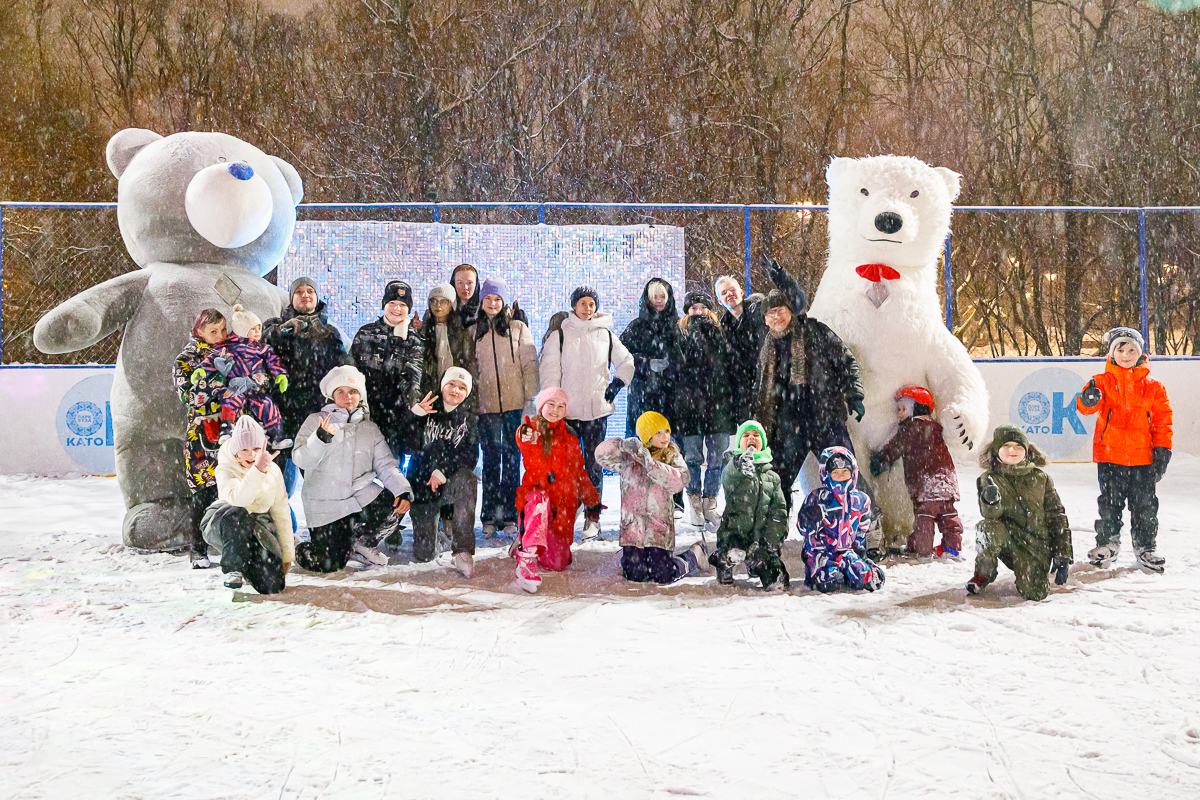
[{"x1": 292, "y1": 403, "x2": 413, "y2": 528}]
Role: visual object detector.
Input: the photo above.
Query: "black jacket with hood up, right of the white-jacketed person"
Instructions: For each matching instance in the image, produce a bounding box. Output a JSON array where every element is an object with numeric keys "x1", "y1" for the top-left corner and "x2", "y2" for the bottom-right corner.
[{"x1": 620, "y1": 278, "x2": 683, "y2": 437}]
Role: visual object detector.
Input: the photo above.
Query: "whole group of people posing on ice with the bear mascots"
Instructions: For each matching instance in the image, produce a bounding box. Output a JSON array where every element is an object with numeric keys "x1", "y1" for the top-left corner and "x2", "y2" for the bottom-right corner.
[{"x1": 175, "y1": 258, "x2": 1171, "y2": 599}]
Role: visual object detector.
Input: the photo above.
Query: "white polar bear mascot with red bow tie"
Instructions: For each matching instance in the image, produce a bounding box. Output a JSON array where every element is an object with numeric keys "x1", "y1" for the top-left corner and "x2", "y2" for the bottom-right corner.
[{"x1": 809, "y1": 156, "x2": 988, "y2": 547}]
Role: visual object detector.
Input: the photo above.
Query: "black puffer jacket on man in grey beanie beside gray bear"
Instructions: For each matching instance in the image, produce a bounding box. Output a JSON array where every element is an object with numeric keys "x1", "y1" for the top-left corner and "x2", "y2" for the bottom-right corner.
[{"x1": 263, "y1": 301, "x2": 350, "y2": 438}]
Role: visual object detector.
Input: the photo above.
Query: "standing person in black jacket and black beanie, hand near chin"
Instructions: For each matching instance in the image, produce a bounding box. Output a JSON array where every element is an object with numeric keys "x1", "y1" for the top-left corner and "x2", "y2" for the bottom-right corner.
[{"x1": 350, "y1": 281, "x2": 425, "y2": 459}]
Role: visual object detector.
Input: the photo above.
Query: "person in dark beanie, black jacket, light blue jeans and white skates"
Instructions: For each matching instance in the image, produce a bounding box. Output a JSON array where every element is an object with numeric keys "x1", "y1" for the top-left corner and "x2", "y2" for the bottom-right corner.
[{"x1": 671, "y1": 291, "x2": 737, "y2": 529}]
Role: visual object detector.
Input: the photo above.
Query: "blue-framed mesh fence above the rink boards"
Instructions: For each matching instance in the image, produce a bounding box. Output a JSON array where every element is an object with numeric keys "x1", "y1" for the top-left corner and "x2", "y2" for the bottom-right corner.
[{"x1": 0, "y1": 203, "x2": 1200, "y2": 363}]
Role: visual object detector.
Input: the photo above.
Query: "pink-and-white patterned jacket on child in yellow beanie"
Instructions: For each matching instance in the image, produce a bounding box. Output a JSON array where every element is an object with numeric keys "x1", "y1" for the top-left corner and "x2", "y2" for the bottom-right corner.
[{"x1": 596, "y1": 437, "x2": 689, "y2": 551}]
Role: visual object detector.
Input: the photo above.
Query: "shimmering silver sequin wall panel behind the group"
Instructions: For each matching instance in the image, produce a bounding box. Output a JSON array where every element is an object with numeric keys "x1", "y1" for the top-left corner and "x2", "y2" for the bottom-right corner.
[{"x1": 278, "y1": 222, "x2": 684, "y2": 435}]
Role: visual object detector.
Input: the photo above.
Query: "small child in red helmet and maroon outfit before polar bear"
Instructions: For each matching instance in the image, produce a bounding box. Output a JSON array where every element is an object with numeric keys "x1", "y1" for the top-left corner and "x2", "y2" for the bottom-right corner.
[{"x1": 871, "y1": 386, "x2": 962, "y2": 558}]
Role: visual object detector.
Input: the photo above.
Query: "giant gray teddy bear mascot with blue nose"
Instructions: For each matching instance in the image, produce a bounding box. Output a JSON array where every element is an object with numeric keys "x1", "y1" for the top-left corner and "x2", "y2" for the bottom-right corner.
[{"x1": 34, "y1": 128, "x2": 304, "y2": 551}]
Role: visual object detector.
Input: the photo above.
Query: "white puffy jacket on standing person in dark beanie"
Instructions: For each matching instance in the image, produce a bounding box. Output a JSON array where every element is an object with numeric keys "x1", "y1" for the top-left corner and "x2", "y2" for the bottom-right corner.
[{"x1": 540, "y1": 313, "x2": 634, "y2": 422}]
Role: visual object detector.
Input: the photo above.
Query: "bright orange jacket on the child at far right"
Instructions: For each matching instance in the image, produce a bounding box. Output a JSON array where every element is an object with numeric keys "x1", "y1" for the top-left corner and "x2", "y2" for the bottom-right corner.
[{"x1": 1075, "y1": 361, "x2": 1171, "y2": 467}]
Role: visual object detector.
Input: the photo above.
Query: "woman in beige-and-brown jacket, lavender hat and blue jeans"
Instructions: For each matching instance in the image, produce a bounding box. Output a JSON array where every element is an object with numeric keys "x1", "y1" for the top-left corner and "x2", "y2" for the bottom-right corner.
[{"x1": 474, "y1": 278, "x2": 538, "y2": 539}]
